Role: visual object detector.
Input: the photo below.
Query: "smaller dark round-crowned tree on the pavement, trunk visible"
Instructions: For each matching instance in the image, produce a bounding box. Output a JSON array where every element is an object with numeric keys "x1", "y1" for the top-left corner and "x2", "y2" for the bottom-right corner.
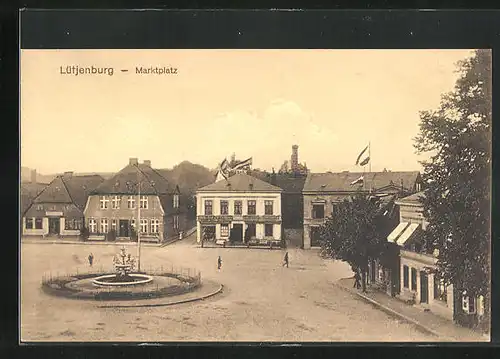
[{"x1": 320, "y1": 192, "x2": 386, "y2": 292}]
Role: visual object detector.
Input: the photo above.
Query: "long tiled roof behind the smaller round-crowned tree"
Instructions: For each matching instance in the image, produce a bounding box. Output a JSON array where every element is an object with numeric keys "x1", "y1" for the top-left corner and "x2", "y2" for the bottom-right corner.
[{"x1": 303, "y1": 171, "x2": 420, "y2": 192}]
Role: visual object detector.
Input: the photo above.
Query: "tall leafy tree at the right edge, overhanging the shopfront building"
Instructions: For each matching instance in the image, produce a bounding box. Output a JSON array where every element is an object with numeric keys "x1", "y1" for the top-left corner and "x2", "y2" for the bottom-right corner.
[{"x1": 415, "y1": 50, "x2": 492, "y2": 324}]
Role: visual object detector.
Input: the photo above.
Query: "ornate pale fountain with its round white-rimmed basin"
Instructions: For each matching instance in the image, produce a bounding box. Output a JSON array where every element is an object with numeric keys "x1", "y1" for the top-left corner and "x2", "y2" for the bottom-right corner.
[{"x1": 92, "y1": 247, "x2": 153, "y2": 287}]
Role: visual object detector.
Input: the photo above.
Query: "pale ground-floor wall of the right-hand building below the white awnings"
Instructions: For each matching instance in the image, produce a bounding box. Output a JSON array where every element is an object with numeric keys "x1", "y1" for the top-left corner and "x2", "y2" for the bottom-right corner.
[{"x1": 400, "y1": 250, "x2": 453, "y2": 320}]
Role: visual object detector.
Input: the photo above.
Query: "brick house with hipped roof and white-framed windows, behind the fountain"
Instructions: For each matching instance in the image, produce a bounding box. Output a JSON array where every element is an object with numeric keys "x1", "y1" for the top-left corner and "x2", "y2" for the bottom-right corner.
[{"x1": 84, "y1": 158, "x2": 187, "y2": 242}]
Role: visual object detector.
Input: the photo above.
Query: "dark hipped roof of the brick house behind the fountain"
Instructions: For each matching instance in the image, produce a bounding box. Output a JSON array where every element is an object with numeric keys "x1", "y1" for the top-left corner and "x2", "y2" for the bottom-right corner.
[{"x1": 91, "y1": 164, "x2": 176, "y2": 195}]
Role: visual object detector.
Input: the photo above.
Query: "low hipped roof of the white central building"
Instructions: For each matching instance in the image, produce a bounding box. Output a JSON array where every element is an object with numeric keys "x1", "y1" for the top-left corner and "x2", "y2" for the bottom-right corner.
[{"x1": 197, "y1": 173, "x2": 283, "y2": 192}]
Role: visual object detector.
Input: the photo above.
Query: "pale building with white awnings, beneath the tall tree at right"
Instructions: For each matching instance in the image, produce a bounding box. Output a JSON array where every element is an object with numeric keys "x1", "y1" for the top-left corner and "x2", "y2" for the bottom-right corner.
[{"x1": 387, "y1": 192, "x2": 484, "y2": 324}]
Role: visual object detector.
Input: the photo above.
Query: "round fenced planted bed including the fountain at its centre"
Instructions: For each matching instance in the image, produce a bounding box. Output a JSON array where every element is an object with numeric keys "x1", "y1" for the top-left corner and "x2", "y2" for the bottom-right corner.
[{"x1": 42, "y1": 247, "x2": 201, "y2": 300}]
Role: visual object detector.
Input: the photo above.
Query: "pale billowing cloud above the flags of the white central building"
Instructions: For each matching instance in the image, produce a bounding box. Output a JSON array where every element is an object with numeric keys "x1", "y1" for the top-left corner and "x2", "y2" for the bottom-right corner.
[{"x1": 201, "y1": 99, "x2": 337, "y2": 169}]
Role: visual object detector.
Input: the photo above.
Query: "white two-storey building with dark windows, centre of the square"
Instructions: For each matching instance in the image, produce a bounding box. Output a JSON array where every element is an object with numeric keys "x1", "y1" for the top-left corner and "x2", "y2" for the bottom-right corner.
[{"x1": 196, "y1": 173, "x2": 282, "y2": 243}]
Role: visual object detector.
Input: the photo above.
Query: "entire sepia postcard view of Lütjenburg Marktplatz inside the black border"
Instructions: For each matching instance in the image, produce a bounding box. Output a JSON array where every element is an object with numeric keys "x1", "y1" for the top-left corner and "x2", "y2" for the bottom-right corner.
[{"x1": 18, "y1": 49, "x2": 492, "y2": 344}]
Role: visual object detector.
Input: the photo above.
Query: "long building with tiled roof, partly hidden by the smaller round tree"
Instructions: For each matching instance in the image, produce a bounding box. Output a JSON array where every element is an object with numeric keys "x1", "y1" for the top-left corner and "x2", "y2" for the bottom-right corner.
[{"x1": 302, "y1": 171, "x2": 422, "y2": 249}]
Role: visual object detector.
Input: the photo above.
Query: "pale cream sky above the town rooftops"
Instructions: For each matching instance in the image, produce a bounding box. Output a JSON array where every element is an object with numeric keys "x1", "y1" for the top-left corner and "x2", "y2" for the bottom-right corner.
[{"x1": 20, "y1": 50, "x2": 472, "y2": 174}]
